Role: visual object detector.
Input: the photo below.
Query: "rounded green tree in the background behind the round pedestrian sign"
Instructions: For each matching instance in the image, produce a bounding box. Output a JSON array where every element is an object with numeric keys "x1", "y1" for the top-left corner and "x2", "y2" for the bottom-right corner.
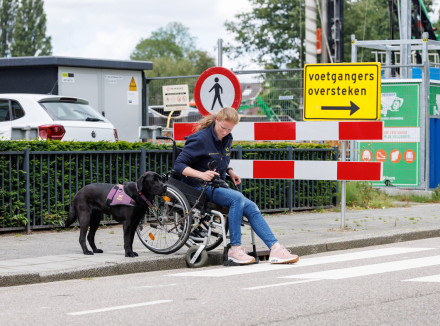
[{"x1": 130, "y1": 22, "x2": 215, "y2": 77}]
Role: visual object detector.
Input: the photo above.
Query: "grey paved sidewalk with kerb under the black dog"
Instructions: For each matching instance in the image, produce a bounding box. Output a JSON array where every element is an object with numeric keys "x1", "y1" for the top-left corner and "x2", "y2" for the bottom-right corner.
[{"x1": 0, "y1": 204, "x2": 440, "y2": 286}]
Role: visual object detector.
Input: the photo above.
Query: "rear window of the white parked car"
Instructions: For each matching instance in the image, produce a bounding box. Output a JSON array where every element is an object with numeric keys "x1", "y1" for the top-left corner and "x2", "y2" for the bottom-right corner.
[{"x1": 40, "y1": 101, "x2": 104, "y2": 121}]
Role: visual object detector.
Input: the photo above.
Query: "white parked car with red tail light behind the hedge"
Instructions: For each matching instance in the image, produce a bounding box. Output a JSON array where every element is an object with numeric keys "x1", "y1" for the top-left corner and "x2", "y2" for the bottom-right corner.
[{"x1": 0, "y1": 94, "x2": 118, "y2": 141}]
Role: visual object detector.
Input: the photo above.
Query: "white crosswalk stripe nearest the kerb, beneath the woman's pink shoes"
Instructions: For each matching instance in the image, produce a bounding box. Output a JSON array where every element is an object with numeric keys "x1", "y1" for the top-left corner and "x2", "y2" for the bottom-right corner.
[{"x1": 169, "y1": 247, "x2": 436, "y2": 277}]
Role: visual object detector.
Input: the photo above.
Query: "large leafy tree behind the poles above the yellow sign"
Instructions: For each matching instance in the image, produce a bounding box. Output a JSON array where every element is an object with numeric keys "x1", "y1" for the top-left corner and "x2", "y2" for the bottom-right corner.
[{"x1": 224, "y1": 0, "x2": 438, "y2": 68}]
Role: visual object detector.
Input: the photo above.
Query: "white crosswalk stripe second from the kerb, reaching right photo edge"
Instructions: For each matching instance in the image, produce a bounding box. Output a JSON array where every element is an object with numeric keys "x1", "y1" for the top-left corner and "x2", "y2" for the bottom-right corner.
[{"x1": 280, "y1": 256, "x2": 440, "y2": 280}]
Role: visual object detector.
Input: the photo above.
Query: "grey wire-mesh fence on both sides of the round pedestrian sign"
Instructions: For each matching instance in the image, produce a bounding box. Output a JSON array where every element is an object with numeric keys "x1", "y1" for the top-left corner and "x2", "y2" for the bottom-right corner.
[{"x1": 147, "y1": 69, "x2": 303, "y2": 129}]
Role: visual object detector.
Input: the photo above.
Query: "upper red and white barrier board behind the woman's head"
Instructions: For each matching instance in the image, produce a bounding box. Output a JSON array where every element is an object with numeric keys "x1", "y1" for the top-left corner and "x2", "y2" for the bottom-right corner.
[{"x1": 174, "y1": 121, "x2": 383, "y2": 141}]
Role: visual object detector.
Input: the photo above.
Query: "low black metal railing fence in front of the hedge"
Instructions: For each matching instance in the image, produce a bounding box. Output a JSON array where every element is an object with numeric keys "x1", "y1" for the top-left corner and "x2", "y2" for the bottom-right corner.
[{"x1": 0, "y1": 147, "x2": 338, "y2": 231}]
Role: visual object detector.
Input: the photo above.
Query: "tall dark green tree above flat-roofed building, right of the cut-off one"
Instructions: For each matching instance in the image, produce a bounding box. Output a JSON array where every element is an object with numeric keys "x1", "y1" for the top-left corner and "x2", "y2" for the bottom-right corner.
[{"x1": 11, "y1": 0, "x2": 52, "y2": 57}]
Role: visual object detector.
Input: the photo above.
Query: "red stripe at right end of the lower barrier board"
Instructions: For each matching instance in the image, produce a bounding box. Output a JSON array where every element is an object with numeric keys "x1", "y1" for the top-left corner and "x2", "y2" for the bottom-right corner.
[{"x1": 337, "y1": 162, "x2": 382, "y2": 181}]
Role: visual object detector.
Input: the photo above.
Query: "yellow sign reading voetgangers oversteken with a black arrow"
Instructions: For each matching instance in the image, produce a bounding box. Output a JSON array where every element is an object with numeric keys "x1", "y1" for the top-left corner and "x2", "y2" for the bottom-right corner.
[{"x1": 303, "y1": 62, "x2": 381, "y2": 120}]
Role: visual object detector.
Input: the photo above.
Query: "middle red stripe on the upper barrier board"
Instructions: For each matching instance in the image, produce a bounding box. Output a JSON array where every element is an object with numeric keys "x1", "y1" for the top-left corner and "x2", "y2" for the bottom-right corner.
[{"x1": 254, "y1": 122, "x2": 296, "y2": 140}]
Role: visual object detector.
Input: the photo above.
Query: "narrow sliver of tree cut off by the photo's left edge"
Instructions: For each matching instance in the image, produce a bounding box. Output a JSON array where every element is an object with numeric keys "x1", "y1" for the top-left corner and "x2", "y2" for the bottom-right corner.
[{"x1": 0, "y1": 0, "x2": 17, "y2": 57}]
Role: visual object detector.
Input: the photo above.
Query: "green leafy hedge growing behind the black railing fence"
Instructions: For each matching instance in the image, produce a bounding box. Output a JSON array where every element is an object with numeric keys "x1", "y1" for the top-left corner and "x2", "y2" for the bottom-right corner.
[{"x1": 0, "y1": 141, "x2": 336, "y2": 228}]
